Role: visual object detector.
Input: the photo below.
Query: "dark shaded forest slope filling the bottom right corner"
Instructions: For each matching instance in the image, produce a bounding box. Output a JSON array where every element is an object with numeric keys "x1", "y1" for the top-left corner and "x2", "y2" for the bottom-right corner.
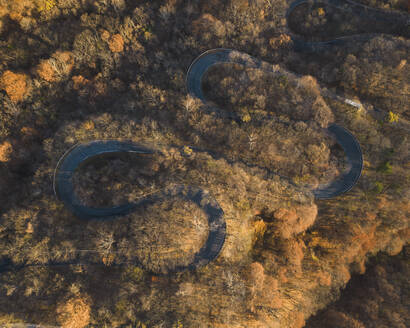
[{"x1": 305, "y1": 246, "x2": 410, "y2": 328}]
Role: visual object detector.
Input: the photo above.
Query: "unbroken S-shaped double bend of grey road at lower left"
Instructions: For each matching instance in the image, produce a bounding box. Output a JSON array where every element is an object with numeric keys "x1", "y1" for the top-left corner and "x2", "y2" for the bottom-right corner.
[{"x1": 48, "y1": 140, "x2": 226, "y2": 272}]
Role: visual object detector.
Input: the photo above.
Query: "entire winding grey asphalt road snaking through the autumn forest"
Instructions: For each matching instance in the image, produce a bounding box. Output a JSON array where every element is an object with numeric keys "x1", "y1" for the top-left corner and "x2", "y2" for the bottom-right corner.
[{"x1": 4, "y1": 0, "x2": 410, "y2": 273}]
